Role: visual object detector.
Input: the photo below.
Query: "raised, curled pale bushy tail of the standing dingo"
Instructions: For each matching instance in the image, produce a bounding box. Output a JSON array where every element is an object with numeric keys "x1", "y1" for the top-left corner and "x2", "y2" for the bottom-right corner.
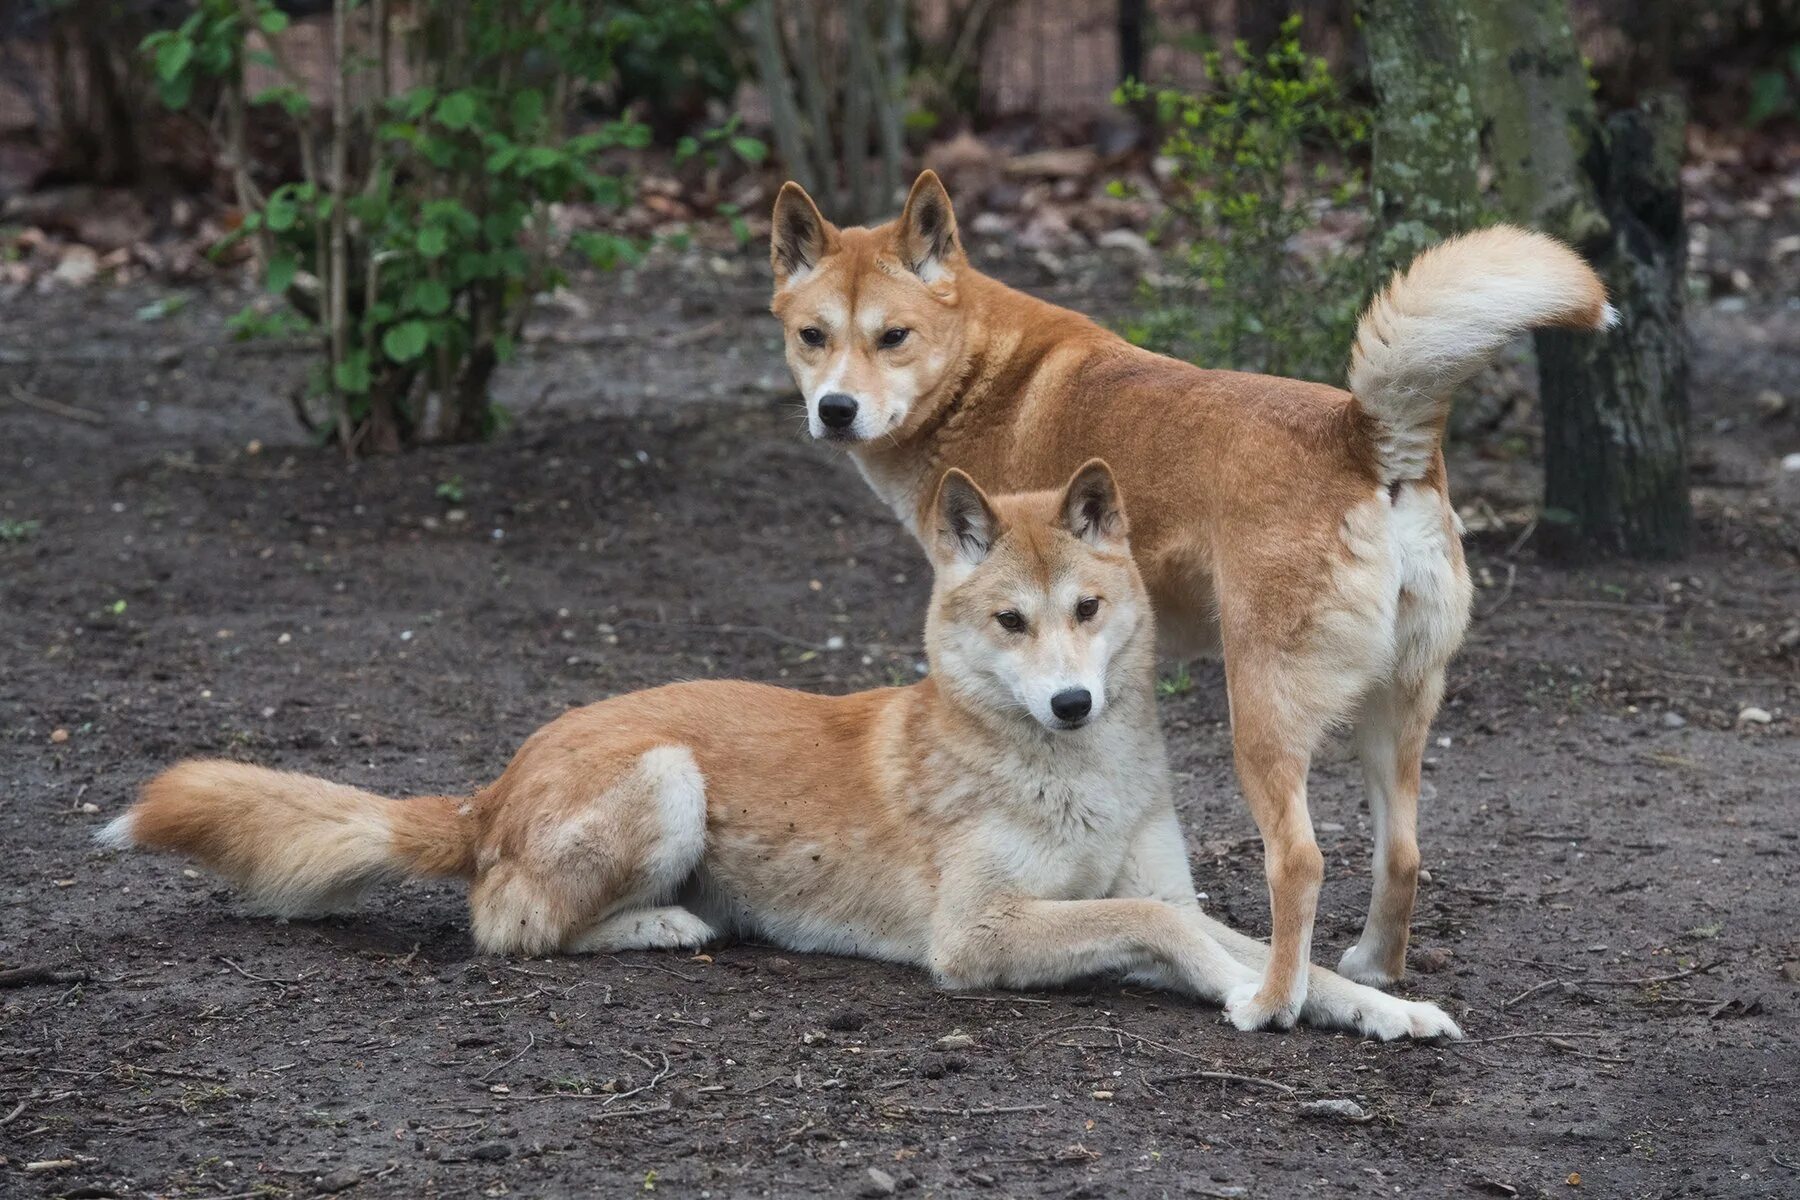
[{"x1": 1350, "y1": 225, "x2": 1618, "y2": 484}]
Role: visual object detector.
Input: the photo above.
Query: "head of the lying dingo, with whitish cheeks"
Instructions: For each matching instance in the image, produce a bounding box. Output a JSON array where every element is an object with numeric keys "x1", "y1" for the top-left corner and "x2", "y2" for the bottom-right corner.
[{"x1": 925, "y1": 459, "x2": 1154, "y2": 730}]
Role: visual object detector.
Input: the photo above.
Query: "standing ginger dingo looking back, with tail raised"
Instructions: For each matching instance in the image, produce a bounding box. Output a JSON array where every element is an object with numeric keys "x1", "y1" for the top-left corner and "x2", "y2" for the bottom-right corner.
[{"x1": 772, "y1": 171, "x2": 1615, "y2": 1027}]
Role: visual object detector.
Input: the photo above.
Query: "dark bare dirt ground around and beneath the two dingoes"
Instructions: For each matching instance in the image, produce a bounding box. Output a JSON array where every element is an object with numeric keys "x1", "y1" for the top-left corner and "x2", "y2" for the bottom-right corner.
[{"x1": 0, "y1": 254, "x2": 1800, "y2": 1198}]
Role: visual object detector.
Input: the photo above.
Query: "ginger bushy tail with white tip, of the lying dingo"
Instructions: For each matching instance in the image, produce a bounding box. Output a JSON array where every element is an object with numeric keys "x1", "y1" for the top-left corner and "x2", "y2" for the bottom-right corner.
[{"x1": 99, "y1": 759, "x2": 475, "y2": 916}]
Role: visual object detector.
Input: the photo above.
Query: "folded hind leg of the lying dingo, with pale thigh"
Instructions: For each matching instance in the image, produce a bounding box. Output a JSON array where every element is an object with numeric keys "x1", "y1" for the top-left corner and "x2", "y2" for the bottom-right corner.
[{"x1": 470, "y1": 747, "x2": 715, "y2": 954}]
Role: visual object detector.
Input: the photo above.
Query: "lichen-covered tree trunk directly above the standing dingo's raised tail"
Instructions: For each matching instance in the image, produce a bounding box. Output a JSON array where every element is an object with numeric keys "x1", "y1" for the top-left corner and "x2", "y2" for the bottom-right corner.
[{"x1": 1363, "y1": 0, "x2": 1481, "y2": 288}]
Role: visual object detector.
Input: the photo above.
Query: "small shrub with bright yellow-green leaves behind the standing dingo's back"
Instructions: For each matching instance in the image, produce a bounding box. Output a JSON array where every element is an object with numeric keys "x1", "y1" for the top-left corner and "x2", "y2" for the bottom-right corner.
[{"x1": 1114, "y1": 16, "x2": 1366, "y2": 381}]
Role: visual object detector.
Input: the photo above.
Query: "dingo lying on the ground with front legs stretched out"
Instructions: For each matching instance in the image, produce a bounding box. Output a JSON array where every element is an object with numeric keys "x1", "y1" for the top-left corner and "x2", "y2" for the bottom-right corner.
[{"x1": 103, "y1": 461, "x2": 1460, "y2": 1038}]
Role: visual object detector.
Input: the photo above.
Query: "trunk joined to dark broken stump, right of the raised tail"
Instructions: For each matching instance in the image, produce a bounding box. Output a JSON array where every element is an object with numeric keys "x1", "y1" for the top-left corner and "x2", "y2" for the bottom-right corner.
[{"x1": 1472, "y1": 0, "x2": 1692, "y2": 560}]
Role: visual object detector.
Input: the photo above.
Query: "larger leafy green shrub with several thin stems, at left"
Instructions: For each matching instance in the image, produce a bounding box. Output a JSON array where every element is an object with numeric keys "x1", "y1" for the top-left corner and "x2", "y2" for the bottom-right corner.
[{"x1": 144, "y1": 0, "x2": 650, "y2": 453}]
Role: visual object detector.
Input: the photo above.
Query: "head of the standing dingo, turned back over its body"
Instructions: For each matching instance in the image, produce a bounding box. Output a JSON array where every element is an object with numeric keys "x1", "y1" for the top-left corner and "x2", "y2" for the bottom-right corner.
[{"x1": 769, "y1": 171, "x2": 968, "y2": 443}]
